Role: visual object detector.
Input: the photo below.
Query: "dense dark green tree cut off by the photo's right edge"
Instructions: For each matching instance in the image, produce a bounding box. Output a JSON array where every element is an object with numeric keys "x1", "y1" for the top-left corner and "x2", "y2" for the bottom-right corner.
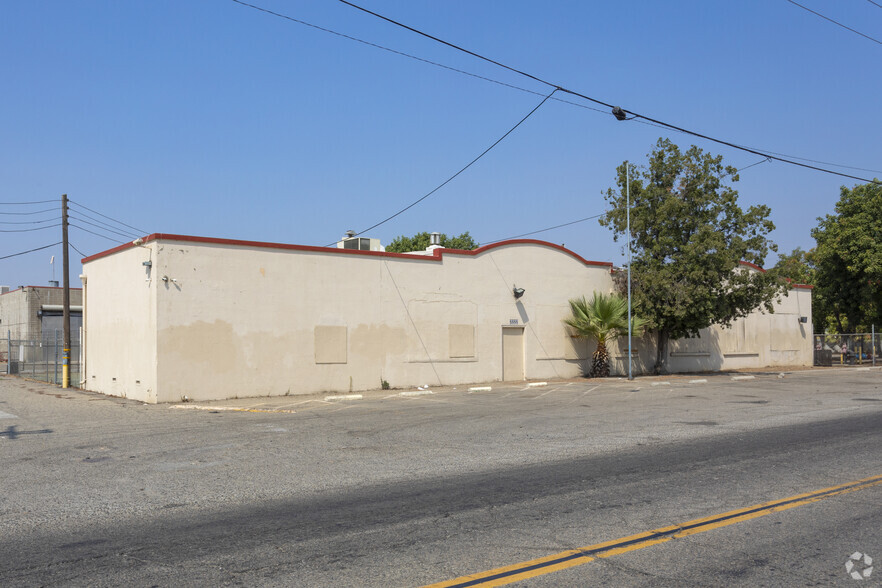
[{"x1": 812, "y1": 183, "x2": 882, "y2": 333}]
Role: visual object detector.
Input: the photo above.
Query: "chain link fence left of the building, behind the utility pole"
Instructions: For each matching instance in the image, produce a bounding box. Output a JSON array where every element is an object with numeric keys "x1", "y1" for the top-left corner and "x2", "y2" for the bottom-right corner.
[{"x1": 0, "y1": 333, "x2": 80, "y2": 386}]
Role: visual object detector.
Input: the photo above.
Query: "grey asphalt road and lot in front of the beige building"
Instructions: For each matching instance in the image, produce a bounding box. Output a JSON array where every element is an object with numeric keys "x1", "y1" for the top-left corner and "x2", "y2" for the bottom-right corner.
[{"x1": 0, "y1": 370, "x2": 882, "y2": 586}]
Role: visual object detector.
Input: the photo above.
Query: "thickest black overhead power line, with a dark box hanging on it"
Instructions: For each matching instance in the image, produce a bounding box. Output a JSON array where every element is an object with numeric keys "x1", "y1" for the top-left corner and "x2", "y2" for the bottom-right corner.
[{"x1": 334, "y1": 0, "x2": 880, "y2": 184}]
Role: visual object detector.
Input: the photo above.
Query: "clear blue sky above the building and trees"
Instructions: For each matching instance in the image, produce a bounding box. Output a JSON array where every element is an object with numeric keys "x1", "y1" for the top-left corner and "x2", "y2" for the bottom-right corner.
[{"x1": 0, "y1": 0, "x2": 882, "y2": 287}]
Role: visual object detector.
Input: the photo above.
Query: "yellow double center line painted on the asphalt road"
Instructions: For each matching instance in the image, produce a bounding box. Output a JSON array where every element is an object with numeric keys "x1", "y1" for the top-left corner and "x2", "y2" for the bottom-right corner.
[{"x1": 426, "y1": 475, "x2": 882, "y2": 588}]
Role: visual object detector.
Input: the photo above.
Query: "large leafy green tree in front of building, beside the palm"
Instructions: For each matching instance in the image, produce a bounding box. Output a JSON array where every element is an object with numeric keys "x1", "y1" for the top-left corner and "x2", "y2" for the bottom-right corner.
[{"x1": 600, "y1": 139, "x2": 784, "y2": 373}]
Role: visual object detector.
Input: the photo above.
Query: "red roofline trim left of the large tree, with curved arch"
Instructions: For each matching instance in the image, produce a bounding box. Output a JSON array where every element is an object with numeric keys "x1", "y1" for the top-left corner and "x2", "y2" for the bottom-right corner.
[{"x1": 82, "y1": 233, "x2": 613, "y2": 269}]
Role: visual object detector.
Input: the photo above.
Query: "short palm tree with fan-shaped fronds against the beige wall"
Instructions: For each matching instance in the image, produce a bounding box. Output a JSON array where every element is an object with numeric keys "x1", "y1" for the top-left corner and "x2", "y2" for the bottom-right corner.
[{"x1": 564, "y1": 292, "x2": 647, "y2": 378}]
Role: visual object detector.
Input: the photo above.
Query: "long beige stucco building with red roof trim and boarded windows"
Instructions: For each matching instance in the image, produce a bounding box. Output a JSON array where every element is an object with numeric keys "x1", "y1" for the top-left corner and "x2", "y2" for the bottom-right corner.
[{"x1": 83, "y1": 234, "x2": 812, "y2": 402}]
